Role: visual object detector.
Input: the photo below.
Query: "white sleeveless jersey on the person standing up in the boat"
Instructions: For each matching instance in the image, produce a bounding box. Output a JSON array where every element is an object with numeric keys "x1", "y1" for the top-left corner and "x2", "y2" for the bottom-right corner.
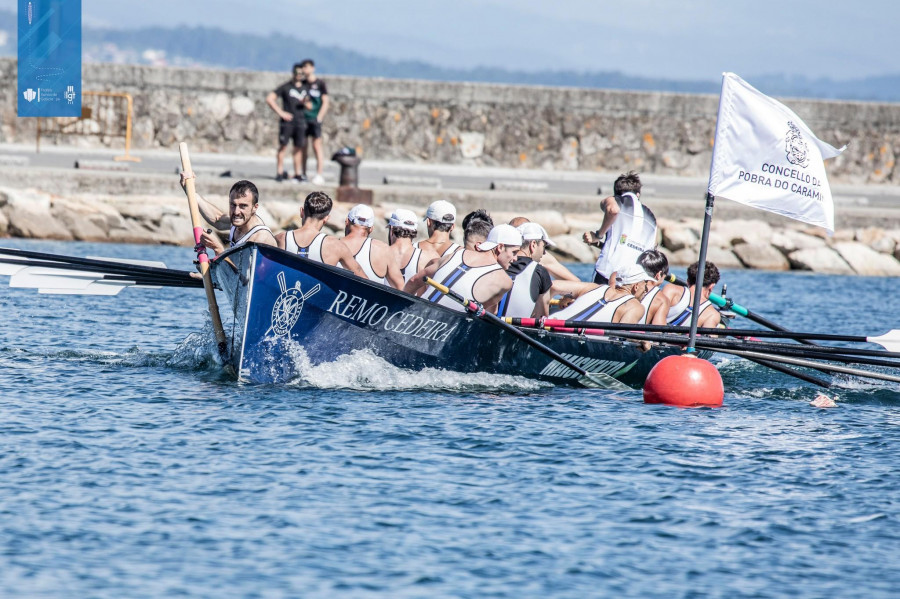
[{"x1": 594, "y1": 192, "x2": 656, "y2": 279}]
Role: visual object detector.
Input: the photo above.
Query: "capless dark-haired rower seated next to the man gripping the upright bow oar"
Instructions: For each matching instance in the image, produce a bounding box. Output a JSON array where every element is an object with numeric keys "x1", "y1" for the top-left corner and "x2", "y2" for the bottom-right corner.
[{"x1": 275, "y1": 191, "x2": 366, "y2": 278}]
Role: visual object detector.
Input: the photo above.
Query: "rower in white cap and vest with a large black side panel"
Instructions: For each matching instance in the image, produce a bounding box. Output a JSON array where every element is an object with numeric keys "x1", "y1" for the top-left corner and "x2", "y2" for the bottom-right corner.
[{"x1": 497, "y1": 223, "x2": 556, "y2": 318}]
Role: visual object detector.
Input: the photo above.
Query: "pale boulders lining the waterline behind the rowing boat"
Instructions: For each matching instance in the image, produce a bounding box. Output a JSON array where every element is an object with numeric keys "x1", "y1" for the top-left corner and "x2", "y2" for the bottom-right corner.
[{"x1": 0, "y1": 188, "x2": 900, "y2": 276}]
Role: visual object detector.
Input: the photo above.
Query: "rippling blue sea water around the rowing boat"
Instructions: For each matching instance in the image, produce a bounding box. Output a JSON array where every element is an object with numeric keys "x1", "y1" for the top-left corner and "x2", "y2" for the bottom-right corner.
[{"x1": 0, "y1": 240, "x2": 900, "y2": 598}]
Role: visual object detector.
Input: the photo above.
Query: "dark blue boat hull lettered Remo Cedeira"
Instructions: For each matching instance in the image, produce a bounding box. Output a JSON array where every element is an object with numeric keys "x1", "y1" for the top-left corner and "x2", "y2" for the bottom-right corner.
[{"x1": 213, "y1": 244, "x2": 678, "y2": 387}]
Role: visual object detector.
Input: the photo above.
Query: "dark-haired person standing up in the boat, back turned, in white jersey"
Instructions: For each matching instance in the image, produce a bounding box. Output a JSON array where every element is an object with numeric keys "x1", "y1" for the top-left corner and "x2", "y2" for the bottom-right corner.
[{"x1": 584, "y1": 171, "x2": 656, "y2": 283}]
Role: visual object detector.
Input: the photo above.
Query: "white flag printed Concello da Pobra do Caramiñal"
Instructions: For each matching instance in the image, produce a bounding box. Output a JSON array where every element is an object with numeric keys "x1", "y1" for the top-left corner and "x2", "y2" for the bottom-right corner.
[{"x1": 708, "y1": 73, "x2": 847, "y2": 233}]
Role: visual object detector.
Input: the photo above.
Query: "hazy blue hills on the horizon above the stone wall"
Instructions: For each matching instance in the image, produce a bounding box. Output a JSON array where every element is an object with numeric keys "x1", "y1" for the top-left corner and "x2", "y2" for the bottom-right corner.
[{"x1": 0, "y1": 11, "x2": 900, "y2": 102}]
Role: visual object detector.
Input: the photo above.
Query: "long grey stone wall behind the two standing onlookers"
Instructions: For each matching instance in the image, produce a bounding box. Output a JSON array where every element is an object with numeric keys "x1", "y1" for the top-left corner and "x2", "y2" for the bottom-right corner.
[{"x1": 0, "y1": 59, "x2": 900, "y2": 184}]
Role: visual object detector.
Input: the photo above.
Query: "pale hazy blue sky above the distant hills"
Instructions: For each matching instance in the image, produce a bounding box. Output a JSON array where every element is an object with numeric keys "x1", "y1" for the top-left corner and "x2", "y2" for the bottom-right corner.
[{"x1": 0, "y1": 0, "x2": 900, "y2": 80}]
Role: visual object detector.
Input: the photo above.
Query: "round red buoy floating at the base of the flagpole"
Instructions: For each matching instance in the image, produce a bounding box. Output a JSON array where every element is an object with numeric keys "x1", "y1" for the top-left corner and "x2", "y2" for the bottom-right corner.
[{"x1": 644, "y1": 355, "x2": 725, "y2": 408}]
